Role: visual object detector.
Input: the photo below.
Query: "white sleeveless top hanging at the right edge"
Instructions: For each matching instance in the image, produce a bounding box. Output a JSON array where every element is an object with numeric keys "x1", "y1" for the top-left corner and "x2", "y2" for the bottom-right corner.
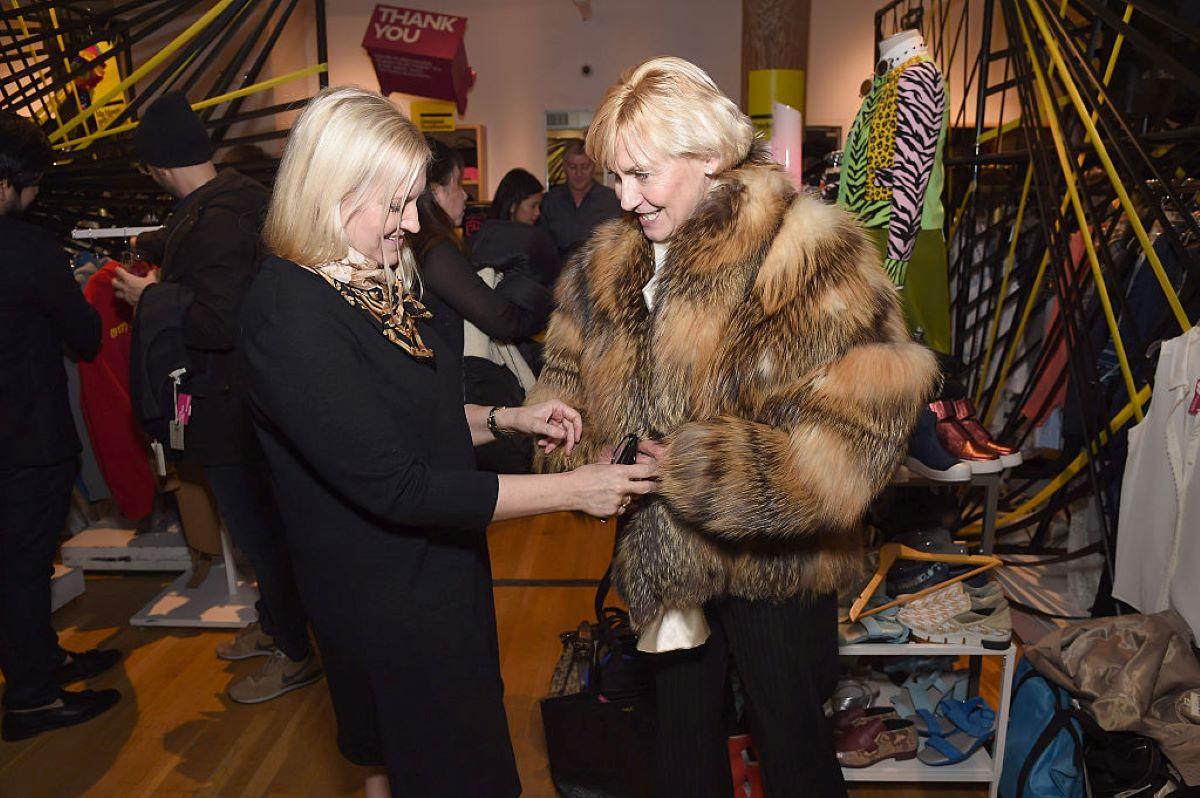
[{"x1": 1112, "y1": 326, "x2": 1200, "y2": 640}]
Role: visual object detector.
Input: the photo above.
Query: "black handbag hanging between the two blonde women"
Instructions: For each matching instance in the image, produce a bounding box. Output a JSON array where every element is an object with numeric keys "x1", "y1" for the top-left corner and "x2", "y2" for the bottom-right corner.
[{"x1": 541, "y1": 439, "x2": 656, "y2": 798}]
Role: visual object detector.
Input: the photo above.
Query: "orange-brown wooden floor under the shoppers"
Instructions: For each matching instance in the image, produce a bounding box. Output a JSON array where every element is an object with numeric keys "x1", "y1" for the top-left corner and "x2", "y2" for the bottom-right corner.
[{"x1": 0, "y1": 515, "x2": 986, "y2": 798}]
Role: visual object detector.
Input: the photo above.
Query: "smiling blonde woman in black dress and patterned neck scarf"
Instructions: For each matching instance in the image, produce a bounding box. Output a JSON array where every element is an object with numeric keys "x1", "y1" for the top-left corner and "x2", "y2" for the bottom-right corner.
[{"x1": 240, "y1": 86, "x2": 654, "y2": 798}]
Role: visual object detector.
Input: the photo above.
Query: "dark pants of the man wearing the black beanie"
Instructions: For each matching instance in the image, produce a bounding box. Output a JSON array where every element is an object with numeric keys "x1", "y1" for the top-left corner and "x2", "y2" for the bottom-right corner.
[{"x1": 204, "y1": 464, "x2": 310, "y2": 660}]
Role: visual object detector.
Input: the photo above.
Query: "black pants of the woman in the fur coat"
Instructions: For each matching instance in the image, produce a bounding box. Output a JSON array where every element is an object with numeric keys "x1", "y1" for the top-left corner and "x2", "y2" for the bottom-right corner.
[{"x1": 655, "y1": 595, "x2": 846, "y2": 798}]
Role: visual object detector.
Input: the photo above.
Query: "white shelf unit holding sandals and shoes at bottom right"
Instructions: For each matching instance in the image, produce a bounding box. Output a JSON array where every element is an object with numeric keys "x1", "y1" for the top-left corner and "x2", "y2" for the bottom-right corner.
[{"x1": 839, "y1": 643, "x2": 1016, "y2": 798}]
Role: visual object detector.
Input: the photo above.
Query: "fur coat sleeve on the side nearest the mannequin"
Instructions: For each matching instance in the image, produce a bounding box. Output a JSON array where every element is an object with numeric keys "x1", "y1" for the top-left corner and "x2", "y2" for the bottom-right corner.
[{"x1": 661, "y1": 208, "x2": 938, "y2": 540}]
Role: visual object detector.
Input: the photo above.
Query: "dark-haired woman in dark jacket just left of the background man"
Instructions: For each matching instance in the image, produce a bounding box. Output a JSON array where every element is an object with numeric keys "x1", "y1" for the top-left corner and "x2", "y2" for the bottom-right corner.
[{"x1": 467, "y1": 169, "x2": 563, "y2": 288}]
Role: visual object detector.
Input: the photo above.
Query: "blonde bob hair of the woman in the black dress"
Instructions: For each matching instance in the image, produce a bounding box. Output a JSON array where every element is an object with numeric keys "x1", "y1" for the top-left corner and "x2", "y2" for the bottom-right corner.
[{"x1": 263, "y1": 86, "x2": 430, "y2": 284}]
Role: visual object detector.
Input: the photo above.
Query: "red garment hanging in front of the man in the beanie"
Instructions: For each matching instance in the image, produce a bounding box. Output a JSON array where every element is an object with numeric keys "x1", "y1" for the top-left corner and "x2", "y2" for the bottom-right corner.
[{"x1": 79, "y1": 255, "x2": 156, "y2": 521}]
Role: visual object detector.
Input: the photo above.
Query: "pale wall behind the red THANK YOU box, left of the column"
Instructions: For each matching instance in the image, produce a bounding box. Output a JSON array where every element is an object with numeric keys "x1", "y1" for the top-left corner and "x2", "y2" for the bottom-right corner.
[{"x1": 324, "y1": 0, "x2": 742, "y2": 198}]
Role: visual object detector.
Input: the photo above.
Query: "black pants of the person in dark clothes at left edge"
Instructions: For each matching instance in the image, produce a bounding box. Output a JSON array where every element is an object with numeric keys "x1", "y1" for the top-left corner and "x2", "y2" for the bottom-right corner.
[{"x1": 0, "y1": 458, "x2": 79, "y2": 709}]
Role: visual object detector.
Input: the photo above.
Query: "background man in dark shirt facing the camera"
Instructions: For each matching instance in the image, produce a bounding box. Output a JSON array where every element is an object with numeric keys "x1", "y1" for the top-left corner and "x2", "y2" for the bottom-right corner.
[{"x1": 540, "y1": 139, "x2": 620, "y2": 263}]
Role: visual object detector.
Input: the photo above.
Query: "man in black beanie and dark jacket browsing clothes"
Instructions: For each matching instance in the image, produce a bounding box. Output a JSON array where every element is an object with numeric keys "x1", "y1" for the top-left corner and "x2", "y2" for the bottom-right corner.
[{"x1": 113, "y1": 92, "x2": 322, "y2": 703}]
